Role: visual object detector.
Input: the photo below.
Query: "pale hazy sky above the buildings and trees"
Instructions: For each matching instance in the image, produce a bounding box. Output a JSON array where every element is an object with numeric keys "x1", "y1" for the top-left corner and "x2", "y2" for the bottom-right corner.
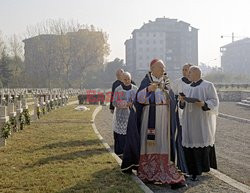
[{"x1": 0, "y1": 0, "x2": 250, "y2": 65}]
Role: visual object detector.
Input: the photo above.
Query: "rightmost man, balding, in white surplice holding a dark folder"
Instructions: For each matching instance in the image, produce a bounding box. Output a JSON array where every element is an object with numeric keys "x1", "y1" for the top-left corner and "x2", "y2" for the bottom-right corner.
[{"x1": 179, "y1": 66, "x2": 219, "y2": 180}]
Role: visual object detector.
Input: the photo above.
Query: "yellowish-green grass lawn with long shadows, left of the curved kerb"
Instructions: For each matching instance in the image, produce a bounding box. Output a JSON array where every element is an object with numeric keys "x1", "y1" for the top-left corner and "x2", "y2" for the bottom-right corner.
[{"x1": 0, "y1": 105, "x2": 142, "y2": 193}]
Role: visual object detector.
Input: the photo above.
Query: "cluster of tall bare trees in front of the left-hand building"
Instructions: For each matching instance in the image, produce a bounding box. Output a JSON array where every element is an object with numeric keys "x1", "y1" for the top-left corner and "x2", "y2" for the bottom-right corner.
[{"x1": 24, "y1": 20, "x2": 109, "y2": 87}]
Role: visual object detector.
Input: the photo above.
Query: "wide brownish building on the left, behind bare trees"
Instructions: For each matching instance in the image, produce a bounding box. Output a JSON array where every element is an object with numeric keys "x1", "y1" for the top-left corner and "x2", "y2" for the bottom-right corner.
[{"x1": 23, "y1": 29, "x2": 105, "y2": 87}]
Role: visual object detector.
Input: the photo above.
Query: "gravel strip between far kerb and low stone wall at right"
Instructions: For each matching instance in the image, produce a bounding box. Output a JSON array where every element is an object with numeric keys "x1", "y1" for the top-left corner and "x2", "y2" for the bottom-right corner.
[{"x1": 219, "y1": 102, "x2": 250, "y2": 119}]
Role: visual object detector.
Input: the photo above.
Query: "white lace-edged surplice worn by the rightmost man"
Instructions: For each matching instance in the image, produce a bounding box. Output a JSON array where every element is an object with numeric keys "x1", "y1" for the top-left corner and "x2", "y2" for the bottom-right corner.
[{"x1": 182, "y1": 80, "x2": 219, "y2": 148}]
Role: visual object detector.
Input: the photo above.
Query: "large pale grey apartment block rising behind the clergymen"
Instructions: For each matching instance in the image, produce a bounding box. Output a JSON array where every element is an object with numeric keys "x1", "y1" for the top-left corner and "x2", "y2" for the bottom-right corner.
[{"x1": 125, "y1": 18, "x2": 198, "y2": 78}]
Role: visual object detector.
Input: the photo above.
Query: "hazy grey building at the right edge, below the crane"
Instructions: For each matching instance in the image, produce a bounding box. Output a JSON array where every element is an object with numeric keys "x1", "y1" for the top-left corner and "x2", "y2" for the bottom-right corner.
[{"x1": 220, "y1": 38, "x2": 250, "y2": 74}]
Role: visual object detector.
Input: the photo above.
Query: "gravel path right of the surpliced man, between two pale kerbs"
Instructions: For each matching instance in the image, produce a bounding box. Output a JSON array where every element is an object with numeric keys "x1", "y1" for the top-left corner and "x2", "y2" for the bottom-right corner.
[{"x1": 215, "y1": 118, "x2": 250, "y2": 185}]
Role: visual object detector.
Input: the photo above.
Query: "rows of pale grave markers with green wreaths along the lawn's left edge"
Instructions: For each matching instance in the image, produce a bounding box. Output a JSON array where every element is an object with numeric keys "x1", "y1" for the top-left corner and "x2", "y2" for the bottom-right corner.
[{"x1": 0, "y1": 88, "x2": 79, "y2": 147}]
